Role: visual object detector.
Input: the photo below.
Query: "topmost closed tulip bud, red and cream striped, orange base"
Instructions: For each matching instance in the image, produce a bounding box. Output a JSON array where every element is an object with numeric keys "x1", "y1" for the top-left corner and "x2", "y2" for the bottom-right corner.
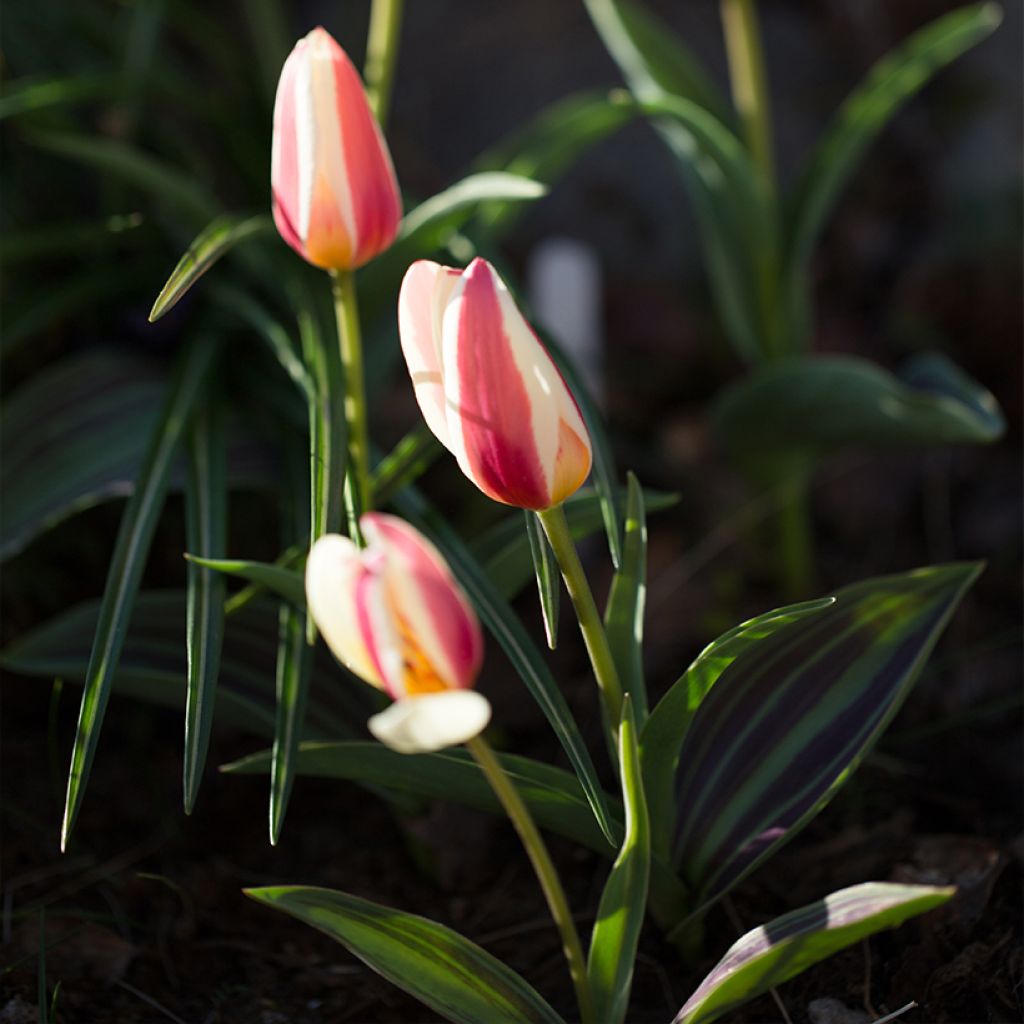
[{"x1": 270, "y1": 29, "x2": 401, "y2": 270}]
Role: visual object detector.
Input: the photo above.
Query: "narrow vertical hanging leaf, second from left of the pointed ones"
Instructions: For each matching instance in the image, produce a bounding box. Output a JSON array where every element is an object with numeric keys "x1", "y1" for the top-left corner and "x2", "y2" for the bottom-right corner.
[{"x1": 182, "y1": 391, "x2": 227, "y2": 814}]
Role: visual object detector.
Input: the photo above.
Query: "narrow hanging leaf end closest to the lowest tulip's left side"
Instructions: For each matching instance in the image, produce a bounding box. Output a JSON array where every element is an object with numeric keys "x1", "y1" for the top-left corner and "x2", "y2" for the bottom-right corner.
[{"x1": 270, "y1": 604, "x2": 312, "y2": 846}]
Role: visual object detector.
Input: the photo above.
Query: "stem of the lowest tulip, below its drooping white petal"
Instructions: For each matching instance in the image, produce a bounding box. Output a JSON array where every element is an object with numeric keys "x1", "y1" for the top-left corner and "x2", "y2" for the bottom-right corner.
[{"x1": 466, "y1": 736, "x2": 596, "y2": 1024}]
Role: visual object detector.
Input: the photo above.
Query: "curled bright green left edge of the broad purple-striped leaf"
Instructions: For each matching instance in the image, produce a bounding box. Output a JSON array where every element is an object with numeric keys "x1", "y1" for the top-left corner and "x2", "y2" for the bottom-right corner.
[{"x1": 640, "y1": 597, "x2": 836, "y2": 857}]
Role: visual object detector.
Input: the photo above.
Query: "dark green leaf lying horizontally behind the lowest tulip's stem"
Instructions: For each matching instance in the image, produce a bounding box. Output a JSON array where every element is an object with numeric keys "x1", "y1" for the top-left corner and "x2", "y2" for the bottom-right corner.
[{"x1": 221, "y1": 741, "x2": 622, "y2": 854}]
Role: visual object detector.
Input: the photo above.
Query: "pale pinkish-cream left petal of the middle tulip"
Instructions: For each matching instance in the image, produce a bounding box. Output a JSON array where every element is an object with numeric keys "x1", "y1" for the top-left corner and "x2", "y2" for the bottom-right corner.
[{"x1": 398, "y1": 259, "x2": 461, "y2": 451}]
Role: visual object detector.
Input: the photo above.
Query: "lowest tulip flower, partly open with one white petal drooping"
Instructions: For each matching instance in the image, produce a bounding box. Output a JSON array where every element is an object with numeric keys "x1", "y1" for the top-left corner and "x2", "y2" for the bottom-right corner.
[{"x1": 306, "y1": 512, "x2": 490, "y2": 754}]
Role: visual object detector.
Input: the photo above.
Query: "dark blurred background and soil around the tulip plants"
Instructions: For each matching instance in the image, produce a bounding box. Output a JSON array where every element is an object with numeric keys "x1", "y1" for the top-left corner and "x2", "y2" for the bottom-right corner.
[{"x1": 0, "y1": 0, "x2": 1024, "y2": 1024}]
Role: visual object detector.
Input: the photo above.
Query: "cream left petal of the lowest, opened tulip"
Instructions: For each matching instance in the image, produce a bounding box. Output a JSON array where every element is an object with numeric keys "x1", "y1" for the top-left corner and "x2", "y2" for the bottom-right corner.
[{"x1": 306, "y1": 534, "x2": 384, "y2": 688}]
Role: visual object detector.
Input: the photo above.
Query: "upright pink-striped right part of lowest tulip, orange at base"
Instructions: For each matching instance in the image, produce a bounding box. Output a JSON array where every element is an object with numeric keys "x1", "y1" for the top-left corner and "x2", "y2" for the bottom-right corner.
[{"x1": 360, "y1": 512, "x2": 483, "y2": 696}]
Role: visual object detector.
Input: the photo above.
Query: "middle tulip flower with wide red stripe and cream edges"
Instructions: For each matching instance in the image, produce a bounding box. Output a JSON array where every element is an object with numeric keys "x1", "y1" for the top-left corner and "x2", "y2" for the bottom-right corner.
[{"x1": 398, "y1": 259, "x2": 591, "y2": 510}]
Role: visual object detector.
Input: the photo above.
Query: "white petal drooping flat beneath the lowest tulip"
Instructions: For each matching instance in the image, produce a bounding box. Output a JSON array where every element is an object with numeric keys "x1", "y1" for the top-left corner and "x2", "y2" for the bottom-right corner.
[{"x1": 367, "y1": 690, "x2": 490, "y2": 754}]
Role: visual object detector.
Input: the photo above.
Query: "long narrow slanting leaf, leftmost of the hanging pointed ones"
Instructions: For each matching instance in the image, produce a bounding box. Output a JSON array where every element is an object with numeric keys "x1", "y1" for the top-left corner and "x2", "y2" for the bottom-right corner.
[{"x1": 60, "y1": 336, "x2": 217, "y2": 850}]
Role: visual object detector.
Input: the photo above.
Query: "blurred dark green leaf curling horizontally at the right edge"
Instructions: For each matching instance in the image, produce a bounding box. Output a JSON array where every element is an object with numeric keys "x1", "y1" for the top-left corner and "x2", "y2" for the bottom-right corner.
[{"x1": 714, "y1": 355, "x2": 1004, "y2": 478}]
